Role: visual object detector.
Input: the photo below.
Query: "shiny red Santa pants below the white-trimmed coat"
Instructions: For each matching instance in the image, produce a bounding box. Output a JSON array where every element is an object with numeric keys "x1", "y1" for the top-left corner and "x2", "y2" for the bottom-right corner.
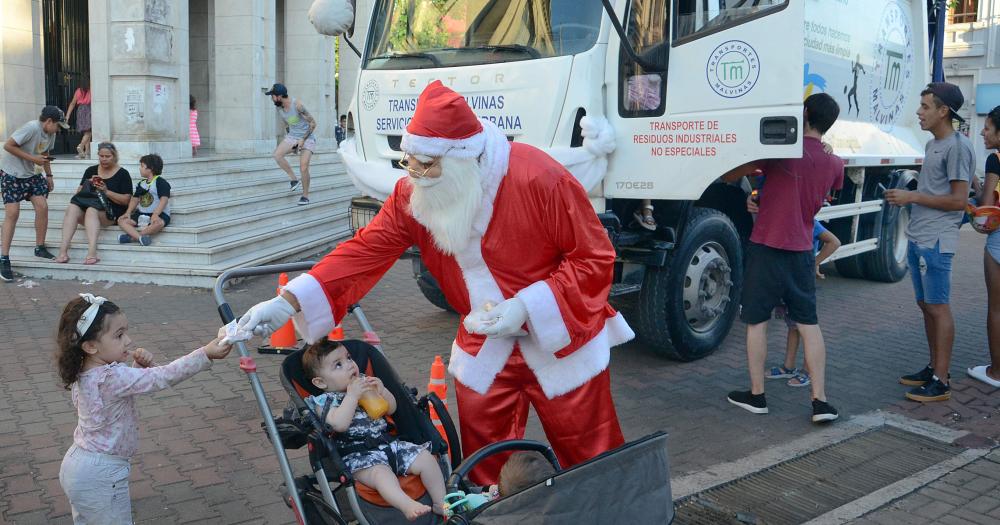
[{"x1": 455, "y1": 349, "x2": 625, "y2": 485}]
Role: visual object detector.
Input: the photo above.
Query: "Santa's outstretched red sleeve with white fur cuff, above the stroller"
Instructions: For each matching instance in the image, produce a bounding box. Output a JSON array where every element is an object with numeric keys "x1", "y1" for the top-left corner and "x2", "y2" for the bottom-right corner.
[{"x1": 285, "y1": 181, "x2": 413, "y2": 343}]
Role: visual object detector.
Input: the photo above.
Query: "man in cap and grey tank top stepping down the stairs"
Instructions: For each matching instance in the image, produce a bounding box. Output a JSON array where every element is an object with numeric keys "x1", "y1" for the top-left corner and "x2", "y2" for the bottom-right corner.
[{"x1": 265, "y1": 84, "x2": 316, "y2": 206}]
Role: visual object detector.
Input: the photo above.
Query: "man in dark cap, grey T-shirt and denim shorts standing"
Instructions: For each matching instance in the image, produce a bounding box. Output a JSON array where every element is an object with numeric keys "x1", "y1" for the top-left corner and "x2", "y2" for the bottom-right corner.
[{"x1": 885, "y1": 82, "x2": 976, "y2": 402}]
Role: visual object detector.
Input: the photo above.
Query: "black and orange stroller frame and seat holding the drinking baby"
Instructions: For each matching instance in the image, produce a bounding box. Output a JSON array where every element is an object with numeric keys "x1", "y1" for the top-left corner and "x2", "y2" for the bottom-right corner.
[{"x1": 215, "y1": 262, "x2": 462, "y2": 525}]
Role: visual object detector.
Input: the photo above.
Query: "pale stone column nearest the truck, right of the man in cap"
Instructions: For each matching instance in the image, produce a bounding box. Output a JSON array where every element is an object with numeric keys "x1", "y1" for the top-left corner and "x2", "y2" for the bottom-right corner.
[{"x1": 278, "y1": 0, "x2": 337, "y2": 149}]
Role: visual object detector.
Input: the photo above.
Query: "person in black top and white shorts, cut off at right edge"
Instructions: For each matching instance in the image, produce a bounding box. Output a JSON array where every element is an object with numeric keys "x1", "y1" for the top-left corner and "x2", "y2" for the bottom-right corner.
[{"x1": 968, "y1": 106, "x2": 1000, "y2": 388}]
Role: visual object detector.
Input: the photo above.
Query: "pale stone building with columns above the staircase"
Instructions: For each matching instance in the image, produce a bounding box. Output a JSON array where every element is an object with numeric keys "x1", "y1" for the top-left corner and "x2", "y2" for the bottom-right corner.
[{"x1": 0, "y1": 0, "x2": 336, "y2": 158}]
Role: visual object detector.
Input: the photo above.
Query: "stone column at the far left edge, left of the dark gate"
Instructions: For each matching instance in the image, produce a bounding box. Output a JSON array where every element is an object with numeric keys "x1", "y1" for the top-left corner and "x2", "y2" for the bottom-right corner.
[{"x1": 0, "y1": 0, "x2": 46, "y2": 136}]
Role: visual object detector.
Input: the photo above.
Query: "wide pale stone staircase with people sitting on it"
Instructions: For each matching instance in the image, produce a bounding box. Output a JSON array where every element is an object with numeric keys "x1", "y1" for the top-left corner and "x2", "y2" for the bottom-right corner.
[{"x1": 0, "y1": 152, "x2": 358, "y2": 288}]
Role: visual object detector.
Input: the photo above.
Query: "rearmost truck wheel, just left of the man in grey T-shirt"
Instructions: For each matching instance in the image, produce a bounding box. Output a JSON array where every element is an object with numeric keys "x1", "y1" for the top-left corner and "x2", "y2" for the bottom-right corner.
[{"x1": 861, "y1": 177, "x2": 910, "y2": 283}]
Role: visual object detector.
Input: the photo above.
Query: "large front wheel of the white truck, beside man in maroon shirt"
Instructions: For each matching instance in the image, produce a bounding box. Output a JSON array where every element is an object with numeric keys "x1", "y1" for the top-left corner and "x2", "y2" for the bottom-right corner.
[{"x1": 636, "y1": 208, "x2": 743, "y2": 361}]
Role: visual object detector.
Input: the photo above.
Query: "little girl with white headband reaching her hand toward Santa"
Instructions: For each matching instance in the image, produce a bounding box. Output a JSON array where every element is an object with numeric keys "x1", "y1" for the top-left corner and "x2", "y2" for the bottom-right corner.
[{"x1": 56, "y1": 294, "x2": 232, "y2": 524}]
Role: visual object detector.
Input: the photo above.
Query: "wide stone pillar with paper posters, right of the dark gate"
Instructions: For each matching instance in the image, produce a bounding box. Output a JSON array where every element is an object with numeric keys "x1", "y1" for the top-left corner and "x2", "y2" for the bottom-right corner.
[{"x1": 90, "y1": 0, "x2": 191, "y2": 158}]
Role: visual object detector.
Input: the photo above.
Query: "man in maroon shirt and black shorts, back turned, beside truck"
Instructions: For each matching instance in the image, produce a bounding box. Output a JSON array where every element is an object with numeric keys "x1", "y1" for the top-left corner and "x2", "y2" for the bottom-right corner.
[{"x1": 723, "y1": 93, "x2": 844, "y2": 422}]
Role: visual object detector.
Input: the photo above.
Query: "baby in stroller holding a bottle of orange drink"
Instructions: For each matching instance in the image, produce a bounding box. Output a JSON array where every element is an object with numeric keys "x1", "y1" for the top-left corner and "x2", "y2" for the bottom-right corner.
[{"x1": 302, "y1": 339, "x2": 445, "y2": 521}]
